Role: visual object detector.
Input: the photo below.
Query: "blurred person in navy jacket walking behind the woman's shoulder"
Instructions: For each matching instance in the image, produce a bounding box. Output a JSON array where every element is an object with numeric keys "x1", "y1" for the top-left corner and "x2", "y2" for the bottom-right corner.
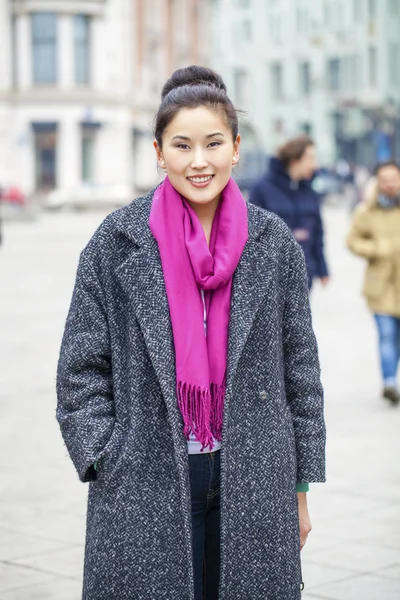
[{"x1": 250, "y1": 135, "x2": 329, "y2": 288}]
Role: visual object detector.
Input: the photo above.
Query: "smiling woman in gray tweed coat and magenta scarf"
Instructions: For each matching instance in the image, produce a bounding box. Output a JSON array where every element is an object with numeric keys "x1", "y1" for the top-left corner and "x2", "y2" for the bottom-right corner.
[{"x1": 57, "y1": 67, "x2": 325, "y2": 600}]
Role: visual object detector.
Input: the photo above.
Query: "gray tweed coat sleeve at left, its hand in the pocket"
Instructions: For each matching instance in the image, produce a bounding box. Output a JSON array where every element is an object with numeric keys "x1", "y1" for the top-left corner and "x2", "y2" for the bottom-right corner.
[{"x1": 57, "y1": 251, "x2": 115, "y2": 481}]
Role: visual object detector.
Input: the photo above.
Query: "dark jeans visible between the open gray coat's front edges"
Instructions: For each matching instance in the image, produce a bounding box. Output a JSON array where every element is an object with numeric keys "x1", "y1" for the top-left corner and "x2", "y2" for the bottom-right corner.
[{"x1": 189, "y1": 451, "x2": 220, "y2": 600}]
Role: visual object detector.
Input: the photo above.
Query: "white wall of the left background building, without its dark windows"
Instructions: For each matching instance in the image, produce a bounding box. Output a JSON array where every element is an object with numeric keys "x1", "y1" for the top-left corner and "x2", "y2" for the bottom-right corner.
[{"x1": 0, "y1": 0, "x2": 139, "y2": 198}]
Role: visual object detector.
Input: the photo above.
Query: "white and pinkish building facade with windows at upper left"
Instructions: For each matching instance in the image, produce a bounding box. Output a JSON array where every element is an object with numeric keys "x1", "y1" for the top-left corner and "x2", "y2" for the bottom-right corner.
[{"x1": 0, "y1": 0, "x2": 210, "y2": 202}]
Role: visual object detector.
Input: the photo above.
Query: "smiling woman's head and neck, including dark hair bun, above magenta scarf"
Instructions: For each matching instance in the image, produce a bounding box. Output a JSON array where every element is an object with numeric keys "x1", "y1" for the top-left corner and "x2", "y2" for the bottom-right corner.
[{"x1": 154, "y1": 66, "x2": 240, "y2": 242}]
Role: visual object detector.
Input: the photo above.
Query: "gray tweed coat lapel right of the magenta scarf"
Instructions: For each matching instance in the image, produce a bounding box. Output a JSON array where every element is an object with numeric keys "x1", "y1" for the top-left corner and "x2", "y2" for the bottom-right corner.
[{"x1": 227, "y1": 207, "x2": 274, "y2": 393}]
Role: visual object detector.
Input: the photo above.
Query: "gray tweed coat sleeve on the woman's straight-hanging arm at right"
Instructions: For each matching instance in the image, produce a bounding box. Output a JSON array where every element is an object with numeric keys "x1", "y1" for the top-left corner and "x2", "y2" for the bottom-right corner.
[{"x1": 283, "y1": 240, "x2": 326, "y2": 484}]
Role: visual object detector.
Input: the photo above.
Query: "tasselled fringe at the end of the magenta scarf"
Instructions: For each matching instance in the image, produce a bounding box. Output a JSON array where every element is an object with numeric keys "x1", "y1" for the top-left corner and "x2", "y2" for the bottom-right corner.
[{"x1": 177, "y1": 381, "x2": 225, "y2": 450}]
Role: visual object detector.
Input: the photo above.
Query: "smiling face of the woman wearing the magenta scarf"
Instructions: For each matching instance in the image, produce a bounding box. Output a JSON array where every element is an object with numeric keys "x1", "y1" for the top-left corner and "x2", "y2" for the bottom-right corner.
[{"x1": 154, "y1": 106, "x2": 240, "y2": 204}]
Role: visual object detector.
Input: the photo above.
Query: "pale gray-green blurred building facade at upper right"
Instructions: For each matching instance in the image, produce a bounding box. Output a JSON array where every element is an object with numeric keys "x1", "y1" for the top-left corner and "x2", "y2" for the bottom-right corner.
[{"x1": 213, "y1": 0, "x2": 400, "y2": 165}]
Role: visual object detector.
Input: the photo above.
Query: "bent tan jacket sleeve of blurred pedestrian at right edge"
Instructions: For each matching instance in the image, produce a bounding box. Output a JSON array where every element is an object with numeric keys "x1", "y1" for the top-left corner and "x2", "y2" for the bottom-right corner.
[{"x1": 347, "y1": 206, "x2": 394, "y2": 260}]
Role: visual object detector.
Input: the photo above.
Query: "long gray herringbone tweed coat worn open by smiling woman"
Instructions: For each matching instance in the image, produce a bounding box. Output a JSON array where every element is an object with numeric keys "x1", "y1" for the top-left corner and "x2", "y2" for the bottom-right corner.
[{"x1": 57, "y1": 194, "x2": 325, "y2": 600}]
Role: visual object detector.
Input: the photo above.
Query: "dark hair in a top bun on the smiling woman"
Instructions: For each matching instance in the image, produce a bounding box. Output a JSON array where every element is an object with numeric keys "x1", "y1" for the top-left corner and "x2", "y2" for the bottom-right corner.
[{"x1": 154, "y1": 65, "x2": 239, "y2": 148}]
